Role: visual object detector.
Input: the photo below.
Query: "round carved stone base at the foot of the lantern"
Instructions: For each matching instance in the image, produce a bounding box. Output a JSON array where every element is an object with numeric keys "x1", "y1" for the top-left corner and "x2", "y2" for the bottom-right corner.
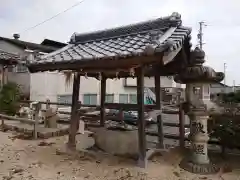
[{"x1": 179, "y1": 158, "x2": 220, "y2": 175}]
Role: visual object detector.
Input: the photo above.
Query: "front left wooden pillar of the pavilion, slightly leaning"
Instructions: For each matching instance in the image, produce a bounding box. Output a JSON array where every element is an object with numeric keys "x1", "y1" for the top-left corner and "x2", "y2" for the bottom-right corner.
[{"x1": 67, "y1": 73, "x2": 81, "y2": 150}]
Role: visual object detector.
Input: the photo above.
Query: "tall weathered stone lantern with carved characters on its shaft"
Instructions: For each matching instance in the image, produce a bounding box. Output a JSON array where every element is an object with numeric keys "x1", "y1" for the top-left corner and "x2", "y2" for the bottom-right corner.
[{"x1": 174, "y1": 47, "x2": 224, "y2": 174}]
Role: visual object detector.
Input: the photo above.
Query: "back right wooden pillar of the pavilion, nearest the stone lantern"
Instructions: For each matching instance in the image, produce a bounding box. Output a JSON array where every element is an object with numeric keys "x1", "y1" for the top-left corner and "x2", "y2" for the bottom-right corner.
[{"x1": 154, "y1": 75, "x2": 164, "y2": 149}]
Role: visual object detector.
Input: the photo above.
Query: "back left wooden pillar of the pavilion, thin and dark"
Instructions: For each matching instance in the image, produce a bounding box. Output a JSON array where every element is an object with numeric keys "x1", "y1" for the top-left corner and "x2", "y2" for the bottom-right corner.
[{"x1": 100, "y1": 76, "x2": 107, "y2": 127}]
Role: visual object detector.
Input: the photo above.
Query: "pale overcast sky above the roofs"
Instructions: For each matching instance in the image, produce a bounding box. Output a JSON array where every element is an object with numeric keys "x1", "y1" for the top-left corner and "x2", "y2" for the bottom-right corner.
[{"x1": 0, "y1": 0, "x2": 240, "y2": 85}]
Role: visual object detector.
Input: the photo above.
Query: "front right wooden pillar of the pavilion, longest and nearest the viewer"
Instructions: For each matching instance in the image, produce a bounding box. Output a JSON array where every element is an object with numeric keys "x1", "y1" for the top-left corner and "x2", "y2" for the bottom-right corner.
[{"x1": 137, "y1": 67, "x2": 147, "y2": 168}]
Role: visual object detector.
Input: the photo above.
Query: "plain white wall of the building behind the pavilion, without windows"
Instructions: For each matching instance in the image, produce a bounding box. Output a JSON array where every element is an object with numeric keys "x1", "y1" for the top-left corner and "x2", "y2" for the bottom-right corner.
[{"x1": 30, "y1": 72, "x2": 184, "y2": 104}]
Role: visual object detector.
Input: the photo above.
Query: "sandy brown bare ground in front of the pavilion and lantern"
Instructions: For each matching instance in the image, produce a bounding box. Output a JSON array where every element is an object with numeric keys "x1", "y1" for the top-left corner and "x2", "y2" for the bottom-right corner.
[{"x1": 0, "y1": 132, "x2": 240, "y2": 180}]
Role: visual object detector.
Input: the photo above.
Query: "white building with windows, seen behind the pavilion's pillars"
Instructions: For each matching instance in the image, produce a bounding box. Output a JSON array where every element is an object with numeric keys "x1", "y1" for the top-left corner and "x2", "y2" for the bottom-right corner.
[{"x1": 30, "y1": 72, "x2": 184, "y2": 104}]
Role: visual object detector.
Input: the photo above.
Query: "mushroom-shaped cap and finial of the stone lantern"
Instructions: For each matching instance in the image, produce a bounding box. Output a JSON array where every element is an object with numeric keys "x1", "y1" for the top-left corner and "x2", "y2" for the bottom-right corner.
[{"x1": 174, "y1": 47, "x2": 224, "y2": 84}]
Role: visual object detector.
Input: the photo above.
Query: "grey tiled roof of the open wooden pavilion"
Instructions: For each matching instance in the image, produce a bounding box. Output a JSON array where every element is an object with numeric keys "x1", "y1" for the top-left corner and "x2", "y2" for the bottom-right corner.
[{"x1": 29, "y1": 13, "x2": 191, "y2": 69}]
